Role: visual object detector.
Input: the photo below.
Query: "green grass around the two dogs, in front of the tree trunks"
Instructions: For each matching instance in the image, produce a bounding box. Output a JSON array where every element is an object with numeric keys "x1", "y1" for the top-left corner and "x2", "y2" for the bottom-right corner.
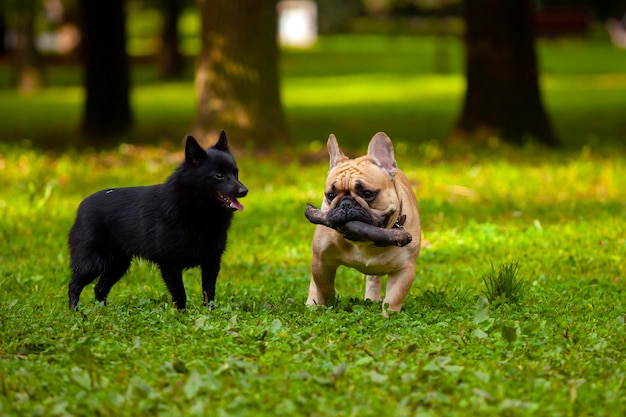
[{"x1": 0, "y1": 139, "x2": 626, "y2": 416}]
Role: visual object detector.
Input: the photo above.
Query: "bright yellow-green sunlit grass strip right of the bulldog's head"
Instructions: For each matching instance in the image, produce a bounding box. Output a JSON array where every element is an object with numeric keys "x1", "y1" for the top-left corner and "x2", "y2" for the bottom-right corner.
[{"x1": 405, "y1": 155, "x2": 626, "y2": 207}]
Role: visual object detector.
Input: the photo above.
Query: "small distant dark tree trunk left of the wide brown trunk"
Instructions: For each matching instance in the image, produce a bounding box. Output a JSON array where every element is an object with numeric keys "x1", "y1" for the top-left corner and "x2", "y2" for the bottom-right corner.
[{"x1": 161, "y1": 0, "x2": 183, "y2": 79}]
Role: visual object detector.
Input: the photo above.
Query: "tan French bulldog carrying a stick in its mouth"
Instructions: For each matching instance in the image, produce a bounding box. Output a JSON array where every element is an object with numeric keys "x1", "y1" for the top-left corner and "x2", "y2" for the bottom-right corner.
[{"x1": 307, "y1": 132, "x2": 421, "y2": 315}]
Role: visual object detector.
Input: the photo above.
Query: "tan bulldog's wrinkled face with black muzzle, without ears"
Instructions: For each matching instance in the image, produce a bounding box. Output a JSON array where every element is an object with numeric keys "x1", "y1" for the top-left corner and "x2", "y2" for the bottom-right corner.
[{"x1": 322, "y1": 156, "x2": 399, "y2": 227}]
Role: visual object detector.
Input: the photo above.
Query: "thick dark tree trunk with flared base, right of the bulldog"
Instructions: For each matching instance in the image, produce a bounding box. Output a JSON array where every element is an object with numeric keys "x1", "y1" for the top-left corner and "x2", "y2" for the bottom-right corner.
[{"x1": 453, "y1": 0, "x2": 558, "y2": 146}]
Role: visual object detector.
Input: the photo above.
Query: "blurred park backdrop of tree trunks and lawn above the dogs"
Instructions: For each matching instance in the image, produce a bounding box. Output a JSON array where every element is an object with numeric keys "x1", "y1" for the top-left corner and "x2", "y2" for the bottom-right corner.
[{"x1": 0, "y1": 0, "x2": 626, "y2": 151}]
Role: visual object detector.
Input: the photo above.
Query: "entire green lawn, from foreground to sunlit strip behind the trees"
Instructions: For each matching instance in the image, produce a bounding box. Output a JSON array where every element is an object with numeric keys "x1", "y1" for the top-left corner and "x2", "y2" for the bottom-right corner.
[{"x1": 0, "y1": 37, "x2": 626, "y2": 416}]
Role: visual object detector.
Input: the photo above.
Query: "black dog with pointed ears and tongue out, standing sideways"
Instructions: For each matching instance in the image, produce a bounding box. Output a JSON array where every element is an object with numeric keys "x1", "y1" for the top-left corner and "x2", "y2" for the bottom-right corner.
[{"x1": 68, "y1": 131, "x2": 248, "y2": 309}]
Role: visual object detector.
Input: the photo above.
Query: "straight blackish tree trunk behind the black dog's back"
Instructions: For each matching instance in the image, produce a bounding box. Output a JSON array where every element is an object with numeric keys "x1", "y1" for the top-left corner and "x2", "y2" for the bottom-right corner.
[{"x1": 79, "y1": 0, "x2": 132, "y2": 144}]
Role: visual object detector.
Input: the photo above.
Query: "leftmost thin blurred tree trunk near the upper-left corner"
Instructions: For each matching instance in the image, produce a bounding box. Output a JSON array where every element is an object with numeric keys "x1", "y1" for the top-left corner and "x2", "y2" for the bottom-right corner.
[{"x1": 12, "y1": 4, "x2": 43, "y2": 94}]
